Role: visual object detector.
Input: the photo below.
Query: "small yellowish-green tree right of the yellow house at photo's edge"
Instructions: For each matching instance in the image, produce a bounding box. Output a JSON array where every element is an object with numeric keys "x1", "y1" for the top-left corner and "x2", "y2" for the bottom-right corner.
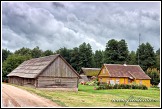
[{"x1": 146, "y1": 68, "x2": 160, "y2": 85}]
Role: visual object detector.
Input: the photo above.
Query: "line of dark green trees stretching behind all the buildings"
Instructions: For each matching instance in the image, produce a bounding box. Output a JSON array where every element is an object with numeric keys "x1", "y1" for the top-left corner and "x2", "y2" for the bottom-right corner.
[{"x1": 2, "y1": 39, "x2": 160, "y2": 84}]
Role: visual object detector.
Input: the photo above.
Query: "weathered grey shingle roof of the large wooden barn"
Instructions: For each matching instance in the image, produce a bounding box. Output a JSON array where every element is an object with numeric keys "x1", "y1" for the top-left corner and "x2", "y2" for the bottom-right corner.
[{"x1": 7, "y1": 54, "x2": 79, "y2": 78}]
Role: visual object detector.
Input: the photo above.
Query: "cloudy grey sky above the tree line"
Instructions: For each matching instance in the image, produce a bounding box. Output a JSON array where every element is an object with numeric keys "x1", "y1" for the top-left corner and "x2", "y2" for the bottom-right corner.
[{"x1": 1, "y1": 2, "x2": 161, "y2": 51}]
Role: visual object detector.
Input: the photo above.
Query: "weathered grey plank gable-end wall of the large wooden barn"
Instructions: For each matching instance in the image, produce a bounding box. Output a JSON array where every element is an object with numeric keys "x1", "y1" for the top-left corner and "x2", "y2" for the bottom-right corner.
[{"x1": 37, "y1": 57, "x2": 78, "y2": 88}]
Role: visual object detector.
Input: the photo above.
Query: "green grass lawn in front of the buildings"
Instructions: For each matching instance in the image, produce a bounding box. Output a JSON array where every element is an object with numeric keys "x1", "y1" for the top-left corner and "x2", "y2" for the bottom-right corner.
[{"x1": 7, "y1": 85, "x2": 160, "y2": 107}]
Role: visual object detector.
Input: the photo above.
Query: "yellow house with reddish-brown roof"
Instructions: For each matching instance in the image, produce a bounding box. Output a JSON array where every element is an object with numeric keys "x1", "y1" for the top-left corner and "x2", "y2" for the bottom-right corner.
[{"x1": 98, "y1": 64, "x2": 151, "y2": 87}]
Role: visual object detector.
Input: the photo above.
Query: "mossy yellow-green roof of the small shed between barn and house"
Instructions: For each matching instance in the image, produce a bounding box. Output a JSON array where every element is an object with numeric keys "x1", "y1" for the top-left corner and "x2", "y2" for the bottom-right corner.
[{"x1": 81, "y1": 68, "x2": 101, "y2": 76}]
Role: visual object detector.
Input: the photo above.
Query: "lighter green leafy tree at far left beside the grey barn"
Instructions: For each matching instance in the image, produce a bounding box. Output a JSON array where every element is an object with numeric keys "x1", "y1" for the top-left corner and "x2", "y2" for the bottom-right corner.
[{"x1": 2, "y1": 54, "x2": 30, "y2": 81}]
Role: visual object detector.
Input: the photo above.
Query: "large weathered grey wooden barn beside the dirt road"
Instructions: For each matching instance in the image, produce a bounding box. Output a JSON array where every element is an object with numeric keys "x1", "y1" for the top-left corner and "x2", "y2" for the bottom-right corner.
[{"x1": 7, "y1": 54, "x2": 80, "y2": 89}]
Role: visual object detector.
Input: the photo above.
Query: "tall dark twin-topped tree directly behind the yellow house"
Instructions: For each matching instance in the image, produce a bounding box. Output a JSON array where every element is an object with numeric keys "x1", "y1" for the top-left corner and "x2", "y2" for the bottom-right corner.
[{"x1": 104, "y1": 39, "x2": 129, "y2": 64}]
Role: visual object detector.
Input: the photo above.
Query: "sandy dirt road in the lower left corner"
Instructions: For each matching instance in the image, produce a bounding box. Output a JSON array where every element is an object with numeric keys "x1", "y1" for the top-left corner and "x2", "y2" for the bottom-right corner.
[{"x1": 2, "y1": 84, "x2": 60, "y2": 107}]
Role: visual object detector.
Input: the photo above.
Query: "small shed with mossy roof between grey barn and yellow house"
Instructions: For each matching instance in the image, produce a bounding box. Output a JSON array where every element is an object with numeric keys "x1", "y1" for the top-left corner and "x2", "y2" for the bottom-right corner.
[{"x1": 80, "y1": 67, "x2": 101, "y2": 82}]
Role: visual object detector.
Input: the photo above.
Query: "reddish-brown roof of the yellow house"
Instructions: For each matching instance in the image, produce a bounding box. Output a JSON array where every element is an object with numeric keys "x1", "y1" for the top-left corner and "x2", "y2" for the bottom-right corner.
[{"x1": 104, "y1": 64, "x2": 151, "y2": 79}]
